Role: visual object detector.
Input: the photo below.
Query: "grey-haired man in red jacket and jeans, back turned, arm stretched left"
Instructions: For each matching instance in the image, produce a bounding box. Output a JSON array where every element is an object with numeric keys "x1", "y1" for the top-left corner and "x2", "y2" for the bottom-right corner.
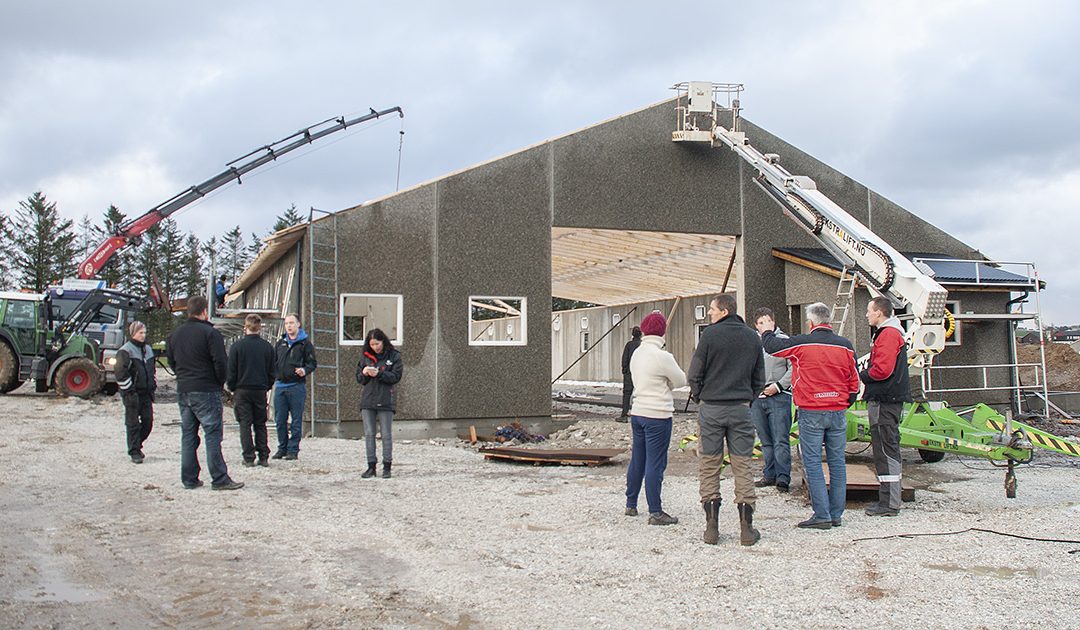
[{"x1": 761, "y1": 301, "x2": 859, "y2": 530}]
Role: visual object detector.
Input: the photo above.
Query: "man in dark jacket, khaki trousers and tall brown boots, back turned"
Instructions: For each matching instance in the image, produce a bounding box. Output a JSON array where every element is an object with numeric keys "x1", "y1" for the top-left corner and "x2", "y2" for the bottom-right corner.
[{"x1": 687, "y1": 293, "x2": 765, "y2": 546}]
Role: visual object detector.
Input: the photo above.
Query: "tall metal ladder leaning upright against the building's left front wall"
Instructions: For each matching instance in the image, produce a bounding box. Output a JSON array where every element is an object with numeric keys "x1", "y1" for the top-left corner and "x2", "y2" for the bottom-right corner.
[{"x1": 308, "y1": 207, "x2": 341, "y2": 435}]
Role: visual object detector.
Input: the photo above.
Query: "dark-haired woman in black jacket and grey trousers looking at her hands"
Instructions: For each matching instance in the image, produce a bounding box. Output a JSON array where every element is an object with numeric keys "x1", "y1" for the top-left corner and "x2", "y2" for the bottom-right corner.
[{"x1": 356, "y1": 329, "x2": 405, "y2": 479}]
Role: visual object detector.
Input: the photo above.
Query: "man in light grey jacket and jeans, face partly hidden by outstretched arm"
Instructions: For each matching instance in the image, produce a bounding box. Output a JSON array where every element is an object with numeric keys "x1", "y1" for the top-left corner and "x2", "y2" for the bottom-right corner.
[{"x1": 750, "y1": 308, "x2": 792, "y2": 492}]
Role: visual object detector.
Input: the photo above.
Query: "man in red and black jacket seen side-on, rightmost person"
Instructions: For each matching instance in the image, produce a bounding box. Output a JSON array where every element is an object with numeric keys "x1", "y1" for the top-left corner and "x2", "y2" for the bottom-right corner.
[{"x1": 859, "y1": 297, "x2": 912, "y2": 517}]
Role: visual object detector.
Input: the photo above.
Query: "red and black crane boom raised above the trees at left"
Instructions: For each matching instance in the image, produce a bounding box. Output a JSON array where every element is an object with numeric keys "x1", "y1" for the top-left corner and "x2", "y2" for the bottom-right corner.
[{"x1": 79, "y1": 107, "x2": 405, "y2": 279}]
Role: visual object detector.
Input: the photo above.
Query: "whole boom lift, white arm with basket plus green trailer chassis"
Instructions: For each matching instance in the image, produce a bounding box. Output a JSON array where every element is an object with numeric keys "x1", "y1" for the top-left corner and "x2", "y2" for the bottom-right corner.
[{"x1": 672, "y1": 81, "x2": 1080, "y2": 498}]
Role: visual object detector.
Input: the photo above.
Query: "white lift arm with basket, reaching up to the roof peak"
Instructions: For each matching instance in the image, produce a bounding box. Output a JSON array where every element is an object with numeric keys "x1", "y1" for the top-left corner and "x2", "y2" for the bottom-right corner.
[{"x1": 672, "y1": 82, "x2": 948, "y2": 367}]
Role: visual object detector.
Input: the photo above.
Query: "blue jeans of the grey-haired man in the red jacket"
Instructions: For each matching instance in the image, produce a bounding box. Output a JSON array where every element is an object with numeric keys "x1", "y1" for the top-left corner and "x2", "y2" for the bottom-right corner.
[{"x1": 799, "y1": 410, "x2": 848, "y2": 521}]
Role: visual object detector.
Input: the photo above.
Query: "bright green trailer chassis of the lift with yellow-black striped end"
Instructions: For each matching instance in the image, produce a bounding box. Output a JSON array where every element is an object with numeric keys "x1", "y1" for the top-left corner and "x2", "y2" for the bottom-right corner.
[{"x1": 679, "y1": 402, "x2": 1080, "y2": 498}]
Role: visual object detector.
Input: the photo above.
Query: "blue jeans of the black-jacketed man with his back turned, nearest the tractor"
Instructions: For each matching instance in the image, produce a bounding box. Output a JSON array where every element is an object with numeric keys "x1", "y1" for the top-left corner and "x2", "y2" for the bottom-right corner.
[{"x1": 177, "y1": 391, "x2": 232, "y2": 486}]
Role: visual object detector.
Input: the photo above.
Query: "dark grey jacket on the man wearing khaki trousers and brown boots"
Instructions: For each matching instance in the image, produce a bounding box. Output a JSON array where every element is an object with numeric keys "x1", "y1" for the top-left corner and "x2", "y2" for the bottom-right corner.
[{"x1": 687, "y1": 314, "x2": 765, "y2": 404}]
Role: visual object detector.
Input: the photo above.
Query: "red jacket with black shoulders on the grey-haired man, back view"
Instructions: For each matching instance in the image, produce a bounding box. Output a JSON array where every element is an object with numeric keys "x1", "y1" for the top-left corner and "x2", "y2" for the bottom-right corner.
[{"x1": 761, "y1": 324, "x2": 859, "y2": 412}]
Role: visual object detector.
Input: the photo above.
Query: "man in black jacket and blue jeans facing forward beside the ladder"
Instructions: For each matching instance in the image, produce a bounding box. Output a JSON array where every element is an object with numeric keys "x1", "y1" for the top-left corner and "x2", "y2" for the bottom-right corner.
[{"x1": 273, "y1": 313, "x2": 316, "y2": 459}]
